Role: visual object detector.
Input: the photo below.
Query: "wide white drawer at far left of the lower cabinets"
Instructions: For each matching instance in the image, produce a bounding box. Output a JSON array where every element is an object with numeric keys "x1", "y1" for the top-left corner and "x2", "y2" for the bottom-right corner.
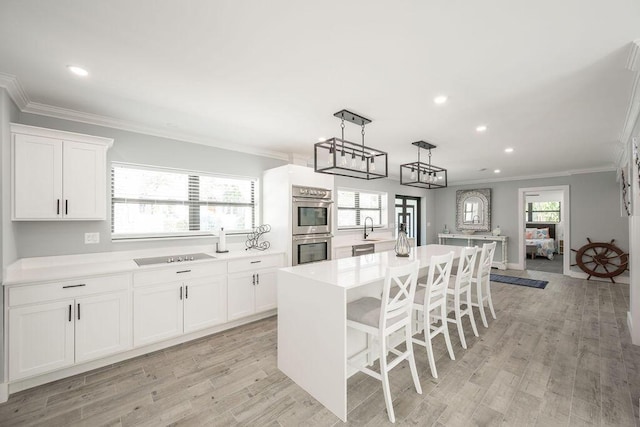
[{"x1": 9, "y1": 274, "x2": 131, "y2": 307}]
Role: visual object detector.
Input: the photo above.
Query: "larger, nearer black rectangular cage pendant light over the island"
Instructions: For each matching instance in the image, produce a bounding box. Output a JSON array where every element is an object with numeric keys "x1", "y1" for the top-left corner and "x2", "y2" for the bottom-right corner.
[{"x1": 313, "y1": 110, "x2": 388, "y2": 180}]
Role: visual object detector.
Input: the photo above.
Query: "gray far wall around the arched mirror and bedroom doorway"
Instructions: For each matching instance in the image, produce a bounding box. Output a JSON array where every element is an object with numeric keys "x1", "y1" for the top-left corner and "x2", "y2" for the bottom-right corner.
[{"x1": 435, "y1": 172, "x2": 629, "y2": 270}]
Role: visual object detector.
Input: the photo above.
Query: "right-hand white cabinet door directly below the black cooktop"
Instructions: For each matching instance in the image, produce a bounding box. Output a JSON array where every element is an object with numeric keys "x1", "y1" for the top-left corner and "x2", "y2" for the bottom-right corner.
[{"x1": 184, "y1": 276, "x2": 227, "y2": 332}]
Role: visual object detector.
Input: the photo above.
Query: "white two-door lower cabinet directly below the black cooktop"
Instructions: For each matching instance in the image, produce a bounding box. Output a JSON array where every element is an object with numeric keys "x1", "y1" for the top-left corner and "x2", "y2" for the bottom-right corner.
[{"x1": 133, "y1": 270, "x2": 227, "y2": 346}]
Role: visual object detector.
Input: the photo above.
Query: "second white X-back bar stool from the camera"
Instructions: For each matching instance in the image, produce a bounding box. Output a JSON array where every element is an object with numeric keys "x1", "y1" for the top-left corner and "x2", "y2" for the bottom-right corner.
[{"x1": 413, "y1": 252, "x2": 456, "y2": 378}]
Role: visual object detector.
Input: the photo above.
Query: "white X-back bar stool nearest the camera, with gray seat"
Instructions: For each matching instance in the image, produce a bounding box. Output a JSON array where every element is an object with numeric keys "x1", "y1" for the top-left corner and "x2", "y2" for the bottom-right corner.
[{"x1": 347, "y1": 261, "x2": 422, "y2": 423}]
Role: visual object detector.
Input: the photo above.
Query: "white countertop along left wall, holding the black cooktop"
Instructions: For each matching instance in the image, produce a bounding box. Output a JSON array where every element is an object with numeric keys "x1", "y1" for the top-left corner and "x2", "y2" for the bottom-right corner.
[{"x1": 2, "y1": 246, "x2": 282, "y2": 286}]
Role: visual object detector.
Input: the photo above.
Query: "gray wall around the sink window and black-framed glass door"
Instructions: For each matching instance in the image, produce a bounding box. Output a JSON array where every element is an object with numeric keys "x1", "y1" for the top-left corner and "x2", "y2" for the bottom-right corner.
[{"x1": 335, "y1": 176, "x2": 437, "y2": 245}]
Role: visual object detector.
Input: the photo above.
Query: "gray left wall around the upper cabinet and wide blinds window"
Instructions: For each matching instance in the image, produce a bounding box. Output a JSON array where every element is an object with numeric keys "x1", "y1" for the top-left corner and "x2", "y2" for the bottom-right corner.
[{"x1": 13, "y1": 113, "x2": 286, "y2": 258}]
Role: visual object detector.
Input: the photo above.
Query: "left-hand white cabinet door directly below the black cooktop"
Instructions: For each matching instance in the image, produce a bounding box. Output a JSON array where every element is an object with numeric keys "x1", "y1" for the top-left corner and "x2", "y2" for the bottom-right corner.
[{"x1": 133, "y1": 282, "x2": 183, "y2": 346}]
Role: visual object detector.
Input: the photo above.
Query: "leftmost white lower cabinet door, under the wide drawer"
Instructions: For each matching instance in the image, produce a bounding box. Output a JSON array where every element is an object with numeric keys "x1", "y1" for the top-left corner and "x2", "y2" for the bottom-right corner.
[{"x1": 8, "y1": 300, "x2": 75, "y2": 380}]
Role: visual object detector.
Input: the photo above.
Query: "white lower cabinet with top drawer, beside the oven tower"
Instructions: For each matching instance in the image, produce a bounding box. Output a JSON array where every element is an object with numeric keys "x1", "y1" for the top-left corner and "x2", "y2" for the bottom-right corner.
[{"x1": 227, "y1": 255, "x2": 283, "y2": 320}]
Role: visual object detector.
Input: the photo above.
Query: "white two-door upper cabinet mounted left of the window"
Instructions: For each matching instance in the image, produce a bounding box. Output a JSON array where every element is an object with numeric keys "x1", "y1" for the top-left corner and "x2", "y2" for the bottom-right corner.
[{"x1": 11, "y1": 123, "x2": 113, "y2": 221}]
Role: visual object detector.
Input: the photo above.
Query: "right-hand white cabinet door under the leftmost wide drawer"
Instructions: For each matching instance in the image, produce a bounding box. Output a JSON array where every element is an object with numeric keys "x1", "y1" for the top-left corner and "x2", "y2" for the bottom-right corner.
[{"x1": 75, "y1": 291, "x2": 132, "y2": 362}]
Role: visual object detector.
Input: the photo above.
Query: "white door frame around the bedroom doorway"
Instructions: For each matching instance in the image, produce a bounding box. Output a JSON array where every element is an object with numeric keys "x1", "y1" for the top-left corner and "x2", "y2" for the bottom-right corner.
[{"x1": 517, "y1": 185, "x2": 571, "y2": 276}]
